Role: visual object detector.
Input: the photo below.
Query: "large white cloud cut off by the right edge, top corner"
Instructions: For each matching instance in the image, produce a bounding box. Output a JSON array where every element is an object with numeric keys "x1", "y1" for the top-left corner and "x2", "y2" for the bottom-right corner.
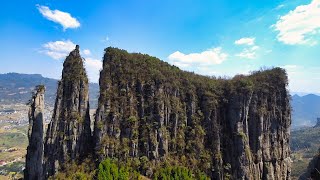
[{"x1": 272, "y1": 0, "x2": 320, "y2": 45}]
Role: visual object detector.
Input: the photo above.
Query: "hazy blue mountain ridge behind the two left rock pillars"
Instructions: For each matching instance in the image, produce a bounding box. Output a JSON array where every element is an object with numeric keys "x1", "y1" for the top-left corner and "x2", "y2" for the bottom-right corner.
[{"x1": 0, "y1": 73, "x2": 99, "y2": 108}]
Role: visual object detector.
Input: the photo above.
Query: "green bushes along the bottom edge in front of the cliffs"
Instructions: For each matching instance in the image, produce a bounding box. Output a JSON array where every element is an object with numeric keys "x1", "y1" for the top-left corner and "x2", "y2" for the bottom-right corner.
[{"x1": 49, "y1": 158, "x2": 210, "y2": 180}]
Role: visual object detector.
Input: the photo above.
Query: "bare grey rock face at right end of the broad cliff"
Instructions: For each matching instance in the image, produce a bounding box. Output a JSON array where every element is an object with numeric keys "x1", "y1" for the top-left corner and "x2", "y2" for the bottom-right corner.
[{"x1": 224, "y1": 81, "x2": 291, "y2": 179}]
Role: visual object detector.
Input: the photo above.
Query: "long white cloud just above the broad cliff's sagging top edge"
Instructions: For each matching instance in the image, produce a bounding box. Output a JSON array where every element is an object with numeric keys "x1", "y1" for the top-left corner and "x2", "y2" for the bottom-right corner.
[{"x1": 168, "y1": 47, "x2": 228, "y2": 68}]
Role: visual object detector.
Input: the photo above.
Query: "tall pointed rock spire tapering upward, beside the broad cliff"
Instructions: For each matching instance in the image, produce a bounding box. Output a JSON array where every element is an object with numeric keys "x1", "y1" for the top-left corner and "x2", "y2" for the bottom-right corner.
[{"x1": 44, "y1": 45, "x2": 92, "y2": 177}]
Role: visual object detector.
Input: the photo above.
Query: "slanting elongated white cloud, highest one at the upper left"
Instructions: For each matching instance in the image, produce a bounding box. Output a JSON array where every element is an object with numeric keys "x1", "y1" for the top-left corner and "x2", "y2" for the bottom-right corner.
[{"x1": 37, "y1": 5, "x2": 80, "y2": 30}]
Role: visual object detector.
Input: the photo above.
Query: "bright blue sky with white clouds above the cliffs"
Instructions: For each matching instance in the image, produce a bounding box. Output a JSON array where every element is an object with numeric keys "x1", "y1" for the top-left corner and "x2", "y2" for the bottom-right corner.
[{"x1": 0, "y1": 0, "x2": 320, "y2": 93}]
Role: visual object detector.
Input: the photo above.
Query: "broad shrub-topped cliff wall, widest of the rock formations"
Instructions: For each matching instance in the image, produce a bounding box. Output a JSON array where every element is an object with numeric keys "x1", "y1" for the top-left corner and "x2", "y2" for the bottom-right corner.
[{"x1": 94, "y1": 48, "x2": 291, "y2": 179}]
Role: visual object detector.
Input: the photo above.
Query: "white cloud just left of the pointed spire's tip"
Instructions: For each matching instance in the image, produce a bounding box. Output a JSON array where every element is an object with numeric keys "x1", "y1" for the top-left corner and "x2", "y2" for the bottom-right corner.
[{"x1": 41, "y1": 40, "x2": 76, "y2": 60}]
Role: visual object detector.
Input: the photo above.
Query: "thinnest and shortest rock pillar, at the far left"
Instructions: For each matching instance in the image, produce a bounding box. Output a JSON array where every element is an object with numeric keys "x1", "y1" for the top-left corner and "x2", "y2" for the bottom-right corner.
[{"x1": 24, "y1": 85, "x2": 45, "y2": 180}]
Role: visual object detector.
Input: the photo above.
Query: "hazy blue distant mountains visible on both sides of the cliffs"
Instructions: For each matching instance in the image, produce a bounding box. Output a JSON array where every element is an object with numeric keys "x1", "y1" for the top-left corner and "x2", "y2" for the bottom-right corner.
[{"x1": 0, "y1": 73, "x2": 320, "y2": 129}]
